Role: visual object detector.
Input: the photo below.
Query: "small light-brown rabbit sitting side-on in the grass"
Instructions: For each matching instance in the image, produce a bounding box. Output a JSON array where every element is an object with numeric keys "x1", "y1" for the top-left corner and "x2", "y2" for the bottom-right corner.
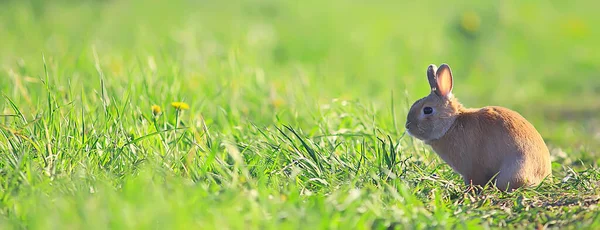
[{"x1": 406, "y1": 64, "x2": 551, "y2": 191}]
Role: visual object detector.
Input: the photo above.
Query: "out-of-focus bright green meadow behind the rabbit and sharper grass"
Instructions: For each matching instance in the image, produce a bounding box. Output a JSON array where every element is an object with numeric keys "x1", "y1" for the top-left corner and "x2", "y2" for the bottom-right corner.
[{"x1": 0, "y1": 1, "x2": 600, "y2": 151}]
